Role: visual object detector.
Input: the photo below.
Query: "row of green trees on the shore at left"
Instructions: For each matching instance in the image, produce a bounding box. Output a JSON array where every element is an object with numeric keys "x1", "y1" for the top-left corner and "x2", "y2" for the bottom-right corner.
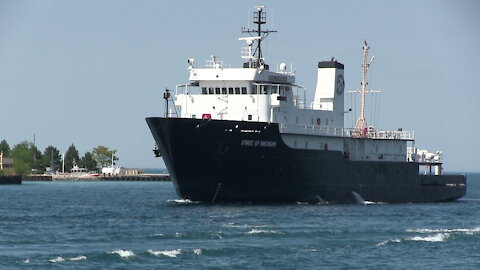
[{"x1": 0, "y1": 140, "x2": 118, "y2": 175}]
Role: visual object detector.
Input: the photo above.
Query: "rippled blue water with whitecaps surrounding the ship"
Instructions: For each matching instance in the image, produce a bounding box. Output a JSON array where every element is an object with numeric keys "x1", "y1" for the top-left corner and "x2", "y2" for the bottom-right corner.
[{"x1": 0, "y1": 174, "x2": 480, "y2": 269}]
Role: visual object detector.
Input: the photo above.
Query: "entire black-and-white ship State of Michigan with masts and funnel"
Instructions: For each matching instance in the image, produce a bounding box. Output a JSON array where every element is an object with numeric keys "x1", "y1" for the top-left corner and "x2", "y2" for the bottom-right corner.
[{"x1": 146, "y1": 6, "x2": 466, "y2": 203}]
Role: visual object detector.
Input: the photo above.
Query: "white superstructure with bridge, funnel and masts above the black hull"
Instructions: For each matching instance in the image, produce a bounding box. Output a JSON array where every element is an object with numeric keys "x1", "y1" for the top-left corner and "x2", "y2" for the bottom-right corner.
[{"x1": 167, "y1": 7, "x2": 442, "y2": 168}]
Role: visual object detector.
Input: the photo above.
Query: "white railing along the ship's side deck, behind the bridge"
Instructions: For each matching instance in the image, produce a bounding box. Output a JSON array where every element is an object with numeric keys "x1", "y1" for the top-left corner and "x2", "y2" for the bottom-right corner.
[{"x1": 279, "y1": 123, "x2": 415, "y2": 141}]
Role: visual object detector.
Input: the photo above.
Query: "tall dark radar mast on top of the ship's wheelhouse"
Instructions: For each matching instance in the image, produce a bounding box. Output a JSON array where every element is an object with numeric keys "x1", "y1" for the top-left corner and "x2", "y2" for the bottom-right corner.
[{"x1": 242, "y1": 6, "x2": 277, "y2": 68}]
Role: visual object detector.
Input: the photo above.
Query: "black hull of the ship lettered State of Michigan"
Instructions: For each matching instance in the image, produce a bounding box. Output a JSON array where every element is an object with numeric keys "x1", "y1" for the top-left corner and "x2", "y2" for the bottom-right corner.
[{"x1": 146, "y1": 117, "x2": 466, "y2": 203}]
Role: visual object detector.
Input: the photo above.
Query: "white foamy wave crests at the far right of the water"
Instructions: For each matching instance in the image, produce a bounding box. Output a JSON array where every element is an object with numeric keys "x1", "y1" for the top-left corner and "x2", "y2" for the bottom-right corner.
[{"x1": 376, "y1": 227, "x2": 480, "y2": 246}]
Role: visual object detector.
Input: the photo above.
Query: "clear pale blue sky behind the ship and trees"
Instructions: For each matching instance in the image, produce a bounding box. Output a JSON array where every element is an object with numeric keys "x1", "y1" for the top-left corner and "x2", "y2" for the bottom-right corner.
[{"x1": 0, "y1": 0, "x2": 480, "y2": 172}]
